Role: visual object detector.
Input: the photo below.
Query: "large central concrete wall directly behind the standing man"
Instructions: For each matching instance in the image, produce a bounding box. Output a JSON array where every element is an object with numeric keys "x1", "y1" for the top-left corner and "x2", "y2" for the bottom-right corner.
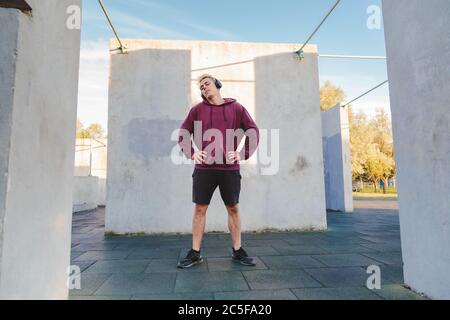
[{"x1": 106, "y1": 40, "x2": 326, "y2": 233}]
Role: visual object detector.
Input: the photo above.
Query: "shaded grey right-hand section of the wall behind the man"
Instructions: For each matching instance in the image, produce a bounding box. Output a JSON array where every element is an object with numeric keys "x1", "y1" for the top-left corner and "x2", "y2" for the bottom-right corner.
[{"x1": 253, "y1": 49, "x2": 327, "y2": 230}]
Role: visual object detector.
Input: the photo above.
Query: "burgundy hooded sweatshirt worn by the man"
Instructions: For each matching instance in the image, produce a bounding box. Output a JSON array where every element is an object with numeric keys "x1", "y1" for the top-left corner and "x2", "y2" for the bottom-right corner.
[{"x1": 178, "y1": 98, "x2": 259, "y2": 170}]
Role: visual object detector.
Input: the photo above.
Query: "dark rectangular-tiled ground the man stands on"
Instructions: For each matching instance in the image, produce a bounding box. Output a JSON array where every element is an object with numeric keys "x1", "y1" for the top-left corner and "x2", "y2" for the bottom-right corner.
[{"x1": 70, "y1": 200, "x2": 423, "y2": 300}]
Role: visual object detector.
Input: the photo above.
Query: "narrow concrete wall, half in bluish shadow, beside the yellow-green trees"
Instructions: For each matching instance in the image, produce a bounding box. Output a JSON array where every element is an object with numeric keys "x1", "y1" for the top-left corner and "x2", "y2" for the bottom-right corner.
[{"x1": 321, "y1": 105, "x2": 353, "y2": 212}]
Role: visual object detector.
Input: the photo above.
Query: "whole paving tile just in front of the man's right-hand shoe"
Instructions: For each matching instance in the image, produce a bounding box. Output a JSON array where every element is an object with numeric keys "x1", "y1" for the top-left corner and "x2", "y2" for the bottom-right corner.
[{"x1": 243, "y1": 269, "x2": 322, "y2": 291}]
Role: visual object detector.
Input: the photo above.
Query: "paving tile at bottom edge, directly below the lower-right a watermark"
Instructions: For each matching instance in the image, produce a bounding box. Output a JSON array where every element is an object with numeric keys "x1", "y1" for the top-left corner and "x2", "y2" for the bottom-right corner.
[{"x1": 292, "y1": 287, "x2": 381, "y2": 300}]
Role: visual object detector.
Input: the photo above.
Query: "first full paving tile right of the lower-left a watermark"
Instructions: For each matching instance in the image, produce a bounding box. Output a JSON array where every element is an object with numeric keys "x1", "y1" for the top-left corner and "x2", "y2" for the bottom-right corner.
[{"x1": 95, "y1": 273, "x2": 176, "y2": 295}]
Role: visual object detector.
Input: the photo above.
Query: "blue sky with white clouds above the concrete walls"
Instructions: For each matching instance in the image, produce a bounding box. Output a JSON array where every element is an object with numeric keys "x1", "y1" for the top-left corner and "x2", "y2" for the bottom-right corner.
[{"x1": 78, "y1": 0, "x2": 390, "y2": 128}]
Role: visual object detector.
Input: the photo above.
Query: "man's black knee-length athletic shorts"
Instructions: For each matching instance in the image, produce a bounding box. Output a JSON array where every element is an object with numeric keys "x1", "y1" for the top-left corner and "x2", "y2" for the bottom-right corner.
[{"x1": 192, "y1": 169, "x2": 242, "y2": 205}]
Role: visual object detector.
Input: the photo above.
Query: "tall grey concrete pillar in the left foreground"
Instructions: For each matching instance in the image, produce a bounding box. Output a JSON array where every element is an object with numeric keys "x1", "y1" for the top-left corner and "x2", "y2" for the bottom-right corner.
[{"x1": 0, "y1": 0, "x2": 81, "y2": 299}]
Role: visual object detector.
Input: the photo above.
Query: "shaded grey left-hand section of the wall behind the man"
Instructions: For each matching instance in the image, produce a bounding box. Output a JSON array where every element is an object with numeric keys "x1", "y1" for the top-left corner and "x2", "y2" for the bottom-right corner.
[{"x1": 106, "y1": 49, "x2": 193, "y2": 233}]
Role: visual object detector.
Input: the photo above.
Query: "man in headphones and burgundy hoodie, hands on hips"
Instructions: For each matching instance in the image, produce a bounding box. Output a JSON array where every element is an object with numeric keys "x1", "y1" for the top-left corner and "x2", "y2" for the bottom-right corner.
[{"x1": 178, "y1": 74, "x2": 259, "y2": 268}]
